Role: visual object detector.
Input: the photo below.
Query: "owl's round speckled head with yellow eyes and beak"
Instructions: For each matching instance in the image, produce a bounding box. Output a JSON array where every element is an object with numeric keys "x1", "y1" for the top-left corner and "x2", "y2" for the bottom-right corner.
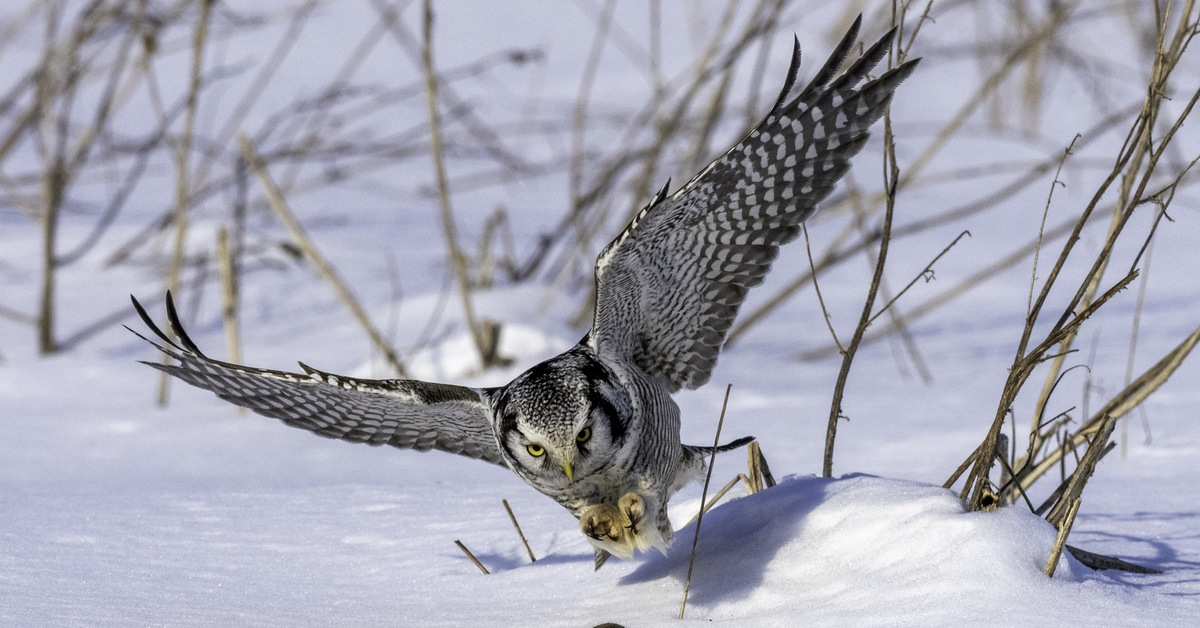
[{"x1": 491, "y1": 351, "x2": 629, "y2": 492}]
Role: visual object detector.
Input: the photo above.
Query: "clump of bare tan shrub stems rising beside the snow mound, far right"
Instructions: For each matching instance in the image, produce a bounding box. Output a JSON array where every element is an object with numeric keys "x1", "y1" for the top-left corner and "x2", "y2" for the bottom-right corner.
[{"x1": 947, "y1": 1, "x2": 1200, "y2": 575}]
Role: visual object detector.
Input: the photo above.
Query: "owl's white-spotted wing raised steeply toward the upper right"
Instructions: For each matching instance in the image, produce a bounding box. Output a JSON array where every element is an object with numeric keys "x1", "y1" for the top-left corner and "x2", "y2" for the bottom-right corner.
[{"x1": 588, "y1": 17, "x2": 917, "y2": 391}]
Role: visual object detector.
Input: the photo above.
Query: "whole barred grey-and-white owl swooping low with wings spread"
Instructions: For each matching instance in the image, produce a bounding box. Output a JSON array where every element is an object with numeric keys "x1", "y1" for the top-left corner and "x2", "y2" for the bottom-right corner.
[{"x1": 134, "y1": 19, "x2": 916, "y2": 566}]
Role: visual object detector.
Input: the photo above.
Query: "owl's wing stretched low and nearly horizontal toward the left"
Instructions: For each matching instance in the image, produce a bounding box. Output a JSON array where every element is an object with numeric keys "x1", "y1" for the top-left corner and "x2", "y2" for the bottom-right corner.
[{"x1": 131, "y1": 293, "x2": 504, "y2": 465}]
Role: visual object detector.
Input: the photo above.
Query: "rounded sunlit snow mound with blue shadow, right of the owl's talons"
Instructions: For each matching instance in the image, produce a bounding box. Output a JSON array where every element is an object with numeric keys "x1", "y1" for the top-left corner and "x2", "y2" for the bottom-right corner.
[{"x1": 604, "y1": 476, "x2": 1196, "y2": 626}]
